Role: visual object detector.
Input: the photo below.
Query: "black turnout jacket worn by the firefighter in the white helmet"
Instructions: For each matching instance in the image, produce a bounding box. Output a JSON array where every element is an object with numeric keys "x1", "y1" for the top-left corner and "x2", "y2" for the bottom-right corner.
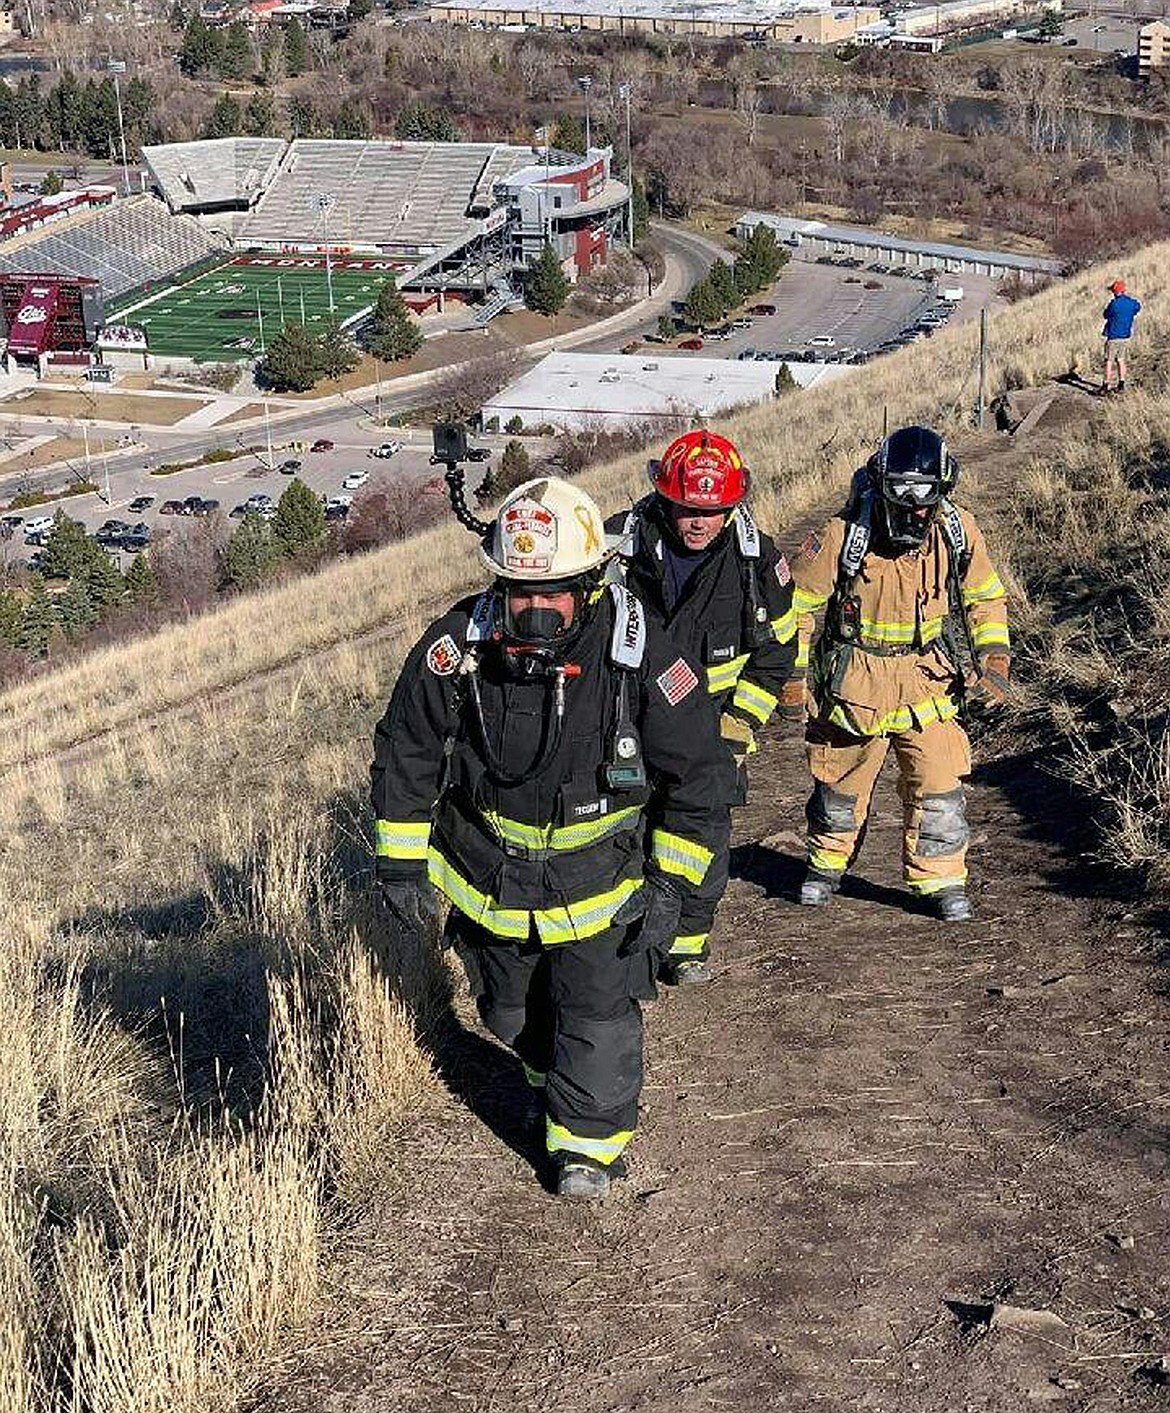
[{"x1": 372, "y1": 586, "x2": 733, "y2": 945}]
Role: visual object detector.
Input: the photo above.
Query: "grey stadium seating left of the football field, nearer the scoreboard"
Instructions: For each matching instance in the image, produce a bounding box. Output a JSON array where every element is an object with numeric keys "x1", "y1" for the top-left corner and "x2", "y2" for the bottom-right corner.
[{"x1": 0, "y1": 196, "x2": 220, "y2": 300}]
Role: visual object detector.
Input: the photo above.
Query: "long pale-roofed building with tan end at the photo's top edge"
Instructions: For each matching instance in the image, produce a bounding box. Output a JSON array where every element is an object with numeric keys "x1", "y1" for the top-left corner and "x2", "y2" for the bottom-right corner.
[{"x1": 430, "y1": 0, "x2": 880, "y2": 44}]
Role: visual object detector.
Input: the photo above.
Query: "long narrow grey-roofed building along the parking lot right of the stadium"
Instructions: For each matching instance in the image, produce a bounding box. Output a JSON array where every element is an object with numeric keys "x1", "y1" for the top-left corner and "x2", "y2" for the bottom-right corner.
[{"x1": 735, "y1": 211, "x2": 1061, "y2": 281}]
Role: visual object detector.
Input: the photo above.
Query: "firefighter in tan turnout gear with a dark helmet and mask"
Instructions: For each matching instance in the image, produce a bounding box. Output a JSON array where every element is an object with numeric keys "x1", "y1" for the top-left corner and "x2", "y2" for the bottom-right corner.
[{"x1": 783, "y1": 427, "x2": 1010, "y2": 921}]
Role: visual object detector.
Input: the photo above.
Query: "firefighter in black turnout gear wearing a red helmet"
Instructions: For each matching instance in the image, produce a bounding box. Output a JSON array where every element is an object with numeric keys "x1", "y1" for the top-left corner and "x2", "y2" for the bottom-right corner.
[{"x1": 606, "y1": 431, "x2": 797, "y2": 985}]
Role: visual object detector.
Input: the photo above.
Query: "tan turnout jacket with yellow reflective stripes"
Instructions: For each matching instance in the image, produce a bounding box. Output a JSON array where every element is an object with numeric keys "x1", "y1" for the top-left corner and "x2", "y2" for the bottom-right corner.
[{"x1": 793, "y1": 502, "x2": 1010, "y2": 736}]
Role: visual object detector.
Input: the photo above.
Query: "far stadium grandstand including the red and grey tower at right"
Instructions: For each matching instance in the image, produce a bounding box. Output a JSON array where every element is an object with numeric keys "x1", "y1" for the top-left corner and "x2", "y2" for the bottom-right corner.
[{"x1": 143, "y1": 137, "x2": 629, "y2": 298}]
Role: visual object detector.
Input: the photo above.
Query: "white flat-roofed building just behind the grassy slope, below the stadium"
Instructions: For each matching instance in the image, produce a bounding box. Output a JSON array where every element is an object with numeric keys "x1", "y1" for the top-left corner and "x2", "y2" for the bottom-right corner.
[{"x1": 480, "y1": 353, "x2": 849, "y2": 432}]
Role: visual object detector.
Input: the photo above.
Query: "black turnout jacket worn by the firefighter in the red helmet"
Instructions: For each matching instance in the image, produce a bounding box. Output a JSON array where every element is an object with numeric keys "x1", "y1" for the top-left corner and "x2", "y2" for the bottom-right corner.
[{"x1": 606, "y1": 495, "x2": 797, "y2": 728}]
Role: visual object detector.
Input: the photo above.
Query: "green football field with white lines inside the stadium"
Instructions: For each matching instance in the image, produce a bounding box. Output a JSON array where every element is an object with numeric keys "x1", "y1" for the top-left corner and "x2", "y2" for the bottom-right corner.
[{"x1": 107, "y1": 260, "x2": 386, "y2": 363}]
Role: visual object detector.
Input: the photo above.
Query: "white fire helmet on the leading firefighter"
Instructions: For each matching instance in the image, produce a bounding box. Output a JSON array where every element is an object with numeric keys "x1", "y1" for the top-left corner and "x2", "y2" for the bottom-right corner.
[{"x1": 479, "y1": 476, "x2": 618, "y2": 584}]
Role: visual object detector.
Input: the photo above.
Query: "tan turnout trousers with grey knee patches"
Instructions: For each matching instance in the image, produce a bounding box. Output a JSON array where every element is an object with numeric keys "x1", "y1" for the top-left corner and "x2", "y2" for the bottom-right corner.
[{"x1": 805, "y1": 721, "x2": 971, "y2": 894}]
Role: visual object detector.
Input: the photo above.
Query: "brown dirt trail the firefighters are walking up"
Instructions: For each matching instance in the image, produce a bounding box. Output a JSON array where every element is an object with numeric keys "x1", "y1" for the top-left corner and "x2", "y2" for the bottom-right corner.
[{"x1": 263, "y1": 398, "x2": 1170, "y2": 1413}]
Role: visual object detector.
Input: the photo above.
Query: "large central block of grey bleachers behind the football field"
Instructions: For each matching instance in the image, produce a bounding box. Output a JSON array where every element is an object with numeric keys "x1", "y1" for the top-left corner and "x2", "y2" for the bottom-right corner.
[{"x1": 236, "y1": 138, "x2": 531, "y2": 253}]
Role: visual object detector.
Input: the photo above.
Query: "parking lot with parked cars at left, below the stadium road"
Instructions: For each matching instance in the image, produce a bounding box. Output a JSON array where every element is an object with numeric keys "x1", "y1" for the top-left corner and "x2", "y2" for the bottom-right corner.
[{"x1": 0, "y1": 422, "x2": 502, "y2": 569}]
